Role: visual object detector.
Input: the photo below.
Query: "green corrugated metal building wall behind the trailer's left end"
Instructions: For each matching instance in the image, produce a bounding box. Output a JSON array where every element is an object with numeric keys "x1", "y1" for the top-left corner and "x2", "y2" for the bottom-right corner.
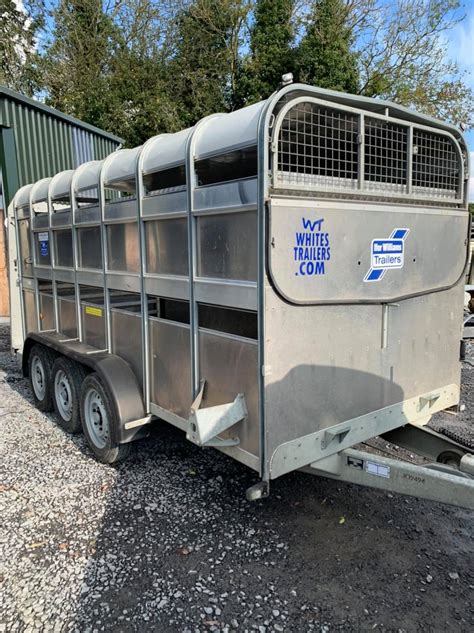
[{"x1": 0, "y1": 86, "x2": 123, "y2": 208}]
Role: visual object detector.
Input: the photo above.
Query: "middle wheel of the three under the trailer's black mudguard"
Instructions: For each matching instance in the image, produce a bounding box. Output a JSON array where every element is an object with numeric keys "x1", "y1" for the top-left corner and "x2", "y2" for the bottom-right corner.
[{"x1": 51, "y1": 356, "x2": 87, "y2": 433}]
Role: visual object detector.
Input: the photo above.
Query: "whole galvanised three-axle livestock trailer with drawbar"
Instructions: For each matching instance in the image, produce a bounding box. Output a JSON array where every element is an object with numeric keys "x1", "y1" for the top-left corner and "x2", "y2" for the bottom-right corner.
[{"x1": 9, "y1": 85, "x2": 474, "y2": 507}]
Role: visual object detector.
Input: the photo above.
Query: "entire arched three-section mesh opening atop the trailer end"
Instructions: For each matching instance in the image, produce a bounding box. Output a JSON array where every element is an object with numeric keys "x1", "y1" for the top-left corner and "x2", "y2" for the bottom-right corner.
[{"x1": 274, "y1": 101, "x2": 462, "y2": 200}]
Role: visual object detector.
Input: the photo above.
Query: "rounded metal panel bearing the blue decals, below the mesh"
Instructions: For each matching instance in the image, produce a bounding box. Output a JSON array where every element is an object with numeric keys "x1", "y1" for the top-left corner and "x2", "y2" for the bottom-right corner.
[{"x1": 268, "y1": 196, "x2": 467, "y2": 304}]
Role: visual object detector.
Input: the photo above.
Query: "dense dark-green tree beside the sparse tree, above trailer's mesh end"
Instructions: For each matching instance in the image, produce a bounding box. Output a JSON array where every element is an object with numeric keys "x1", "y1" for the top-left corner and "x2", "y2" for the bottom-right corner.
[{"x1": 296, "y1": 0, "x2": 358, "y2": 92}]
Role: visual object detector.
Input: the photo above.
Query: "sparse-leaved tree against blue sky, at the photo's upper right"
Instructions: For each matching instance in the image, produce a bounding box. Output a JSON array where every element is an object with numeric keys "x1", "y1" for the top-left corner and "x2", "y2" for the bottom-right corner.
[{"x1": 354, "y1": 0, "x2": 474, "y2": 126}]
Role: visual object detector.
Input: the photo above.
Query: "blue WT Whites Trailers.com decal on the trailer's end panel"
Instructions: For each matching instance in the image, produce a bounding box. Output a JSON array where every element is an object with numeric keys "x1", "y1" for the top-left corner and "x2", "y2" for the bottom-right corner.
[{"x1": 293, "y1": 218, "x2": 331, "y2": 277}]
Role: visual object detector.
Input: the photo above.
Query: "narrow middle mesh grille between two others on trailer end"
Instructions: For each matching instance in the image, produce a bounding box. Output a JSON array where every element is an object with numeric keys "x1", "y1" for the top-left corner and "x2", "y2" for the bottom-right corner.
[{"x1": 364, "y1": 118, "x2": 408, "y2": 192}]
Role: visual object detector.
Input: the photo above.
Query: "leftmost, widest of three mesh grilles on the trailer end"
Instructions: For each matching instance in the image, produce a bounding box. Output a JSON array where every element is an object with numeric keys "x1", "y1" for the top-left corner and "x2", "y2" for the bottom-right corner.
[{"x1": 278, "y1": 102, "x2": 358, "y2": 187}]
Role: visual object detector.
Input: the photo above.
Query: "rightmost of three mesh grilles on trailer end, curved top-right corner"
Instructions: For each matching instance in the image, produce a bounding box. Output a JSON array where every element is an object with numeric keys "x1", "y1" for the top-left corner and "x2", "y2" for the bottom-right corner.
[{"x1": 413, "y1": 130, "x2": 460, "y2": 197}]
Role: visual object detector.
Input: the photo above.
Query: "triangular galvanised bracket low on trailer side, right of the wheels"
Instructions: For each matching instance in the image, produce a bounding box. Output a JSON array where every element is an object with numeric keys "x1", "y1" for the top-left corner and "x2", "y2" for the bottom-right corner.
[{"x1": 186, "y1": 381, "x2": 248, "y2": 447}]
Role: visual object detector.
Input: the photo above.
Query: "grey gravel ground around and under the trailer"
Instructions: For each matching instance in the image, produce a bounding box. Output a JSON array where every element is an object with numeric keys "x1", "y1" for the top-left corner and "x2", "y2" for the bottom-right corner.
[{"x1": 0, "y1": 326, "x2": 474, "y2": 633}]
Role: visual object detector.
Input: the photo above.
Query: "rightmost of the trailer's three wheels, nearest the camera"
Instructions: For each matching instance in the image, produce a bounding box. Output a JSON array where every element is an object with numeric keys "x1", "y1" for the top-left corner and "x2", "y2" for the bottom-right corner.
[{"x1": 81, "y1": 373, "x2": 131, "y2": 464}]
